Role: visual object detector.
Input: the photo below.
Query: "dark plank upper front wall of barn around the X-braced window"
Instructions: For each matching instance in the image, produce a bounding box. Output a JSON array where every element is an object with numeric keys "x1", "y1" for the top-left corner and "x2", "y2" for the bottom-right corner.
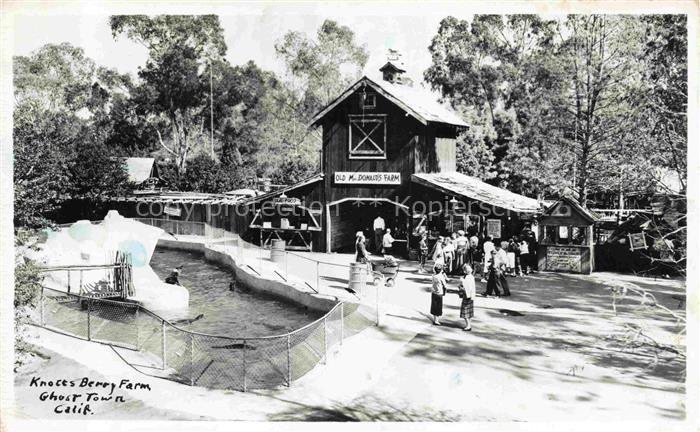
[{"x1": 323, "y1": 89, "x2": 425, "y2": 202}]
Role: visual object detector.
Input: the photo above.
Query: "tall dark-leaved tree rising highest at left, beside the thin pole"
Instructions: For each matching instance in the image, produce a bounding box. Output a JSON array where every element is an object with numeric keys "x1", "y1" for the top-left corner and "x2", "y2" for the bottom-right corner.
[{"x1": 110, "y1": 15, "x2": 226, "y2": 177}]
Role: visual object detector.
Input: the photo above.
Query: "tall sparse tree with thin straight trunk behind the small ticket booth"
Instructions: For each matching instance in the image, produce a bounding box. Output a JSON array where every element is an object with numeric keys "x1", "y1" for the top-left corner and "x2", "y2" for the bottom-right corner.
[{"x1": 562, "y1": 15, "x2": 641, "y2": 205}]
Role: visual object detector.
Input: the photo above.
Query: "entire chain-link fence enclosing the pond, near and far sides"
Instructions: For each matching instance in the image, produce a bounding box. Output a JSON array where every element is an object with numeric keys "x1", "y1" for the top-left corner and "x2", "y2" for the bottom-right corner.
[{"x1": 35, "y1": 218, "x2": 381, "y2": 391}]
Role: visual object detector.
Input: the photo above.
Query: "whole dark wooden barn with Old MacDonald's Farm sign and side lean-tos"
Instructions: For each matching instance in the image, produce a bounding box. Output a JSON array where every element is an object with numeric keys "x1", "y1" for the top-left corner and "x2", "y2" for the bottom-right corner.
[{"x1": 241, "y1": 61, "x2": 541, "y2": 256}]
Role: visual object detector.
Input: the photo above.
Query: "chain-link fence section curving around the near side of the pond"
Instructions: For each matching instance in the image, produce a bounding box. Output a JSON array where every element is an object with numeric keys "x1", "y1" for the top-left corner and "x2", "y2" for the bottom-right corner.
[{"x1": 34, "y1": 287, "x2": 360, "y2": 391}]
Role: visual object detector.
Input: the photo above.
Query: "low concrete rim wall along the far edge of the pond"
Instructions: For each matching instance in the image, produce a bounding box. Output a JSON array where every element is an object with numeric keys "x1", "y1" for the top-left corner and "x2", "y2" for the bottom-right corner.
[{"x1": 157, "y1": 239, "x2": 339, "y2": 313}]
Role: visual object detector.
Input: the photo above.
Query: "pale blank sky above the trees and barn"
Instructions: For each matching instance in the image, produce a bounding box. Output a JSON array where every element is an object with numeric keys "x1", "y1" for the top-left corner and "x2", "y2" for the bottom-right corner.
[{"x1": 11, "y1": 3, "x2": 471, "y2": 82}]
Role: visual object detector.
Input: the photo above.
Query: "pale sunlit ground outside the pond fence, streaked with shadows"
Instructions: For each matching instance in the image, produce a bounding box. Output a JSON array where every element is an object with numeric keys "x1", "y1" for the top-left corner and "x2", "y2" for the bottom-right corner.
[{"x1": 15, "y1": 256, "x2": 686, "y2": 424}]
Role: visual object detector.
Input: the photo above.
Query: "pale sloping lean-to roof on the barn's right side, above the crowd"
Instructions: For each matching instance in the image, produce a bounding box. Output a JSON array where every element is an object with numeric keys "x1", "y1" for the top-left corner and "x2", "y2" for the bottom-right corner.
[{"x1": 411, "y1": 172, "x2": 540, "y2": 213}]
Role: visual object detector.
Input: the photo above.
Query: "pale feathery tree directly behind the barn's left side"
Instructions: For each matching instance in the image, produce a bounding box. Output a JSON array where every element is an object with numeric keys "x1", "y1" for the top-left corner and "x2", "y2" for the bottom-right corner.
[{"x1": 266, "y1": 20, "x2": 369, "y2": 184}]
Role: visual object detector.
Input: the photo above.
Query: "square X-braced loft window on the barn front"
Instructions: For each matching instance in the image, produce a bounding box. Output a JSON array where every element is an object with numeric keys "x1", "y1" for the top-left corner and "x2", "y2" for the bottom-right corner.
[{"x1": 349, "y1": 114, "x2": 386, "y2": 159}]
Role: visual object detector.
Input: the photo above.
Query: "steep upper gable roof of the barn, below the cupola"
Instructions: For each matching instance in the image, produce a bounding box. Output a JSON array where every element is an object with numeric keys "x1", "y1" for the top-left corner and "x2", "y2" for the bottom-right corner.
[{"x1": 309, "y1": 76, "x2": 468, "y2": 127}]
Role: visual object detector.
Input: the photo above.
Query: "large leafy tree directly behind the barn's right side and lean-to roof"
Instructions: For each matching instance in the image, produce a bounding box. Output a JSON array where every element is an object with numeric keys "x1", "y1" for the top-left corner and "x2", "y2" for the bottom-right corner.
[{"x1": 424, "y1": 15, "x2": 561, "y2": 194}]
